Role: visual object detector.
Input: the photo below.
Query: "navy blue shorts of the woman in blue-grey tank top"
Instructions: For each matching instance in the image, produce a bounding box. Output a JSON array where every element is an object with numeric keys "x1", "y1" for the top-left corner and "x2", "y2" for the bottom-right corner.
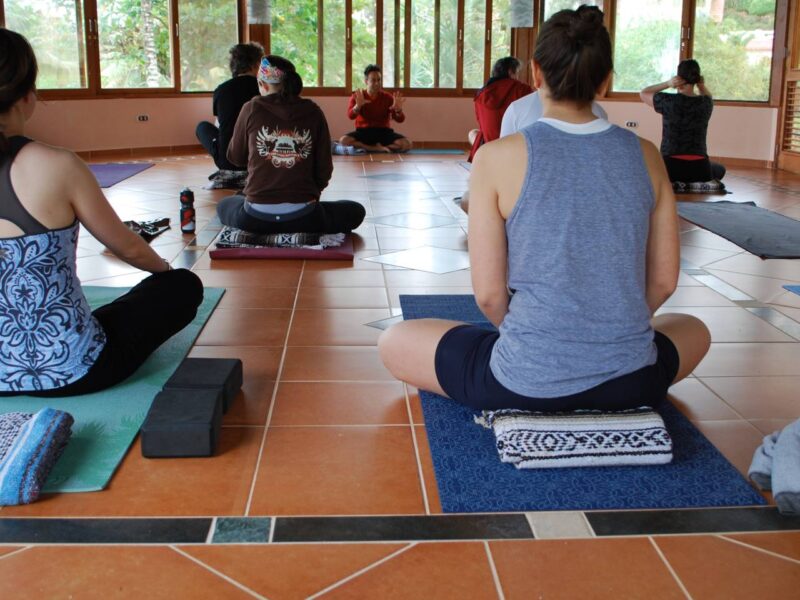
[{"x1": 435, "y1": 325, "x2": 679, "y2": 412}]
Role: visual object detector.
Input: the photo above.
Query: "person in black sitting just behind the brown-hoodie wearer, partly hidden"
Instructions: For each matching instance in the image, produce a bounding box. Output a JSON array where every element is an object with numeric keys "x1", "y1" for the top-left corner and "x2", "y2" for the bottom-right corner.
[{"x1": 195, "y1": 42, "x2": 264, "y2": 180}]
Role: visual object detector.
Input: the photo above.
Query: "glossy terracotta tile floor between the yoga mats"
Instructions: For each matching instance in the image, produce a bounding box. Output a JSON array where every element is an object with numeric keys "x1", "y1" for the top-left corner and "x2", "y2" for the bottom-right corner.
[{"x1": 0, "y1": 155, "x2": 800, "y2": 599}]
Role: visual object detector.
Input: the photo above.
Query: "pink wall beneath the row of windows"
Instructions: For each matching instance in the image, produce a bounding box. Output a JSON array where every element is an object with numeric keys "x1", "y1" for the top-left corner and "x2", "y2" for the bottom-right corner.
[{"x1": 28, "y1": 97, "x2": 778, "y2": 161}]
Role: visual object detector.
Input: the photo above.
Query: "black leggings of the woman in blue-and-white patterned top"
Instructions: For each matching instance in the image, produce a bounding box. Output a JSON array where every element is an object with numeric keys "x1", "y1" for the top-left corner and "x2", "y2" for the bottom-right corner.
[{"x1": 16, "y1": 269, "x2": 203, "y2": 398}]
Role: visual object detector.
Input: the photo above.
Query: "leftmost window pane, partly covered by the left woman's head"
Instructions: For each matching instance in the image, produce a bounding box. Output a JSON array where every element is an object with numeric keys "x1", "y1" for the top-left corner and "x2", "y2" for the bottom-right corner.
[{"x1": 5, "y1": 0, "x2": 87, "y2": 89}]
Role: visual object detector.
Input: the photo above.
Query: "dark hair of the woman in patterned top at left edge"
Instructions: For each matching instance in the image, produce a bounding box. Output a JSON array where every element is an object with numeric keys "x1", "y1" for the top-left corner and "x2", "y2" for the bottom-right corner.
[{"x1": 0, "y1": 27, "x2": 39, "y2": 156}]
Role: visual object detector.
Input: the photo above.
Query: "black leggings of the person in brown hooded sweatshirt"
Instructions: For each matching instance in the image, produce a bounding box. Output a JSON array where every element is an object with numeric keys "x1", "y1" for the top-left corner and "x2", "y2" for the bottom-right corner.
[{"x1": 217, "y1": 196, "x2": 366, "y2": 233}]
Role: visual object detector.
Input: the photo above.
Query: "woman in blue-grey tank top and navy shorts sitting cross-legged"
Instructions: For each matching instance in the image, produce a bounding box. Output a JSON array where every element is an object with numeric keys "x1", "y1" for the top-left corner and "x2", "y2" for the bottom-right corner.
[{"x1": 379, "y1": 6, "x2": 710, "y2": 411}]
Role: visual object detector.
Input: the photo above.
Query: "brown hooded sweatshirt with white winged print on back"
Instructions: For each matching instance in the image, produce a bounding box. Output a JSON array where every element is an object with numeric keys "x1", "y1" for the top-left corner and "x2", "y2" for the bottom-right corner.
[{"x1": 228, "y1": 94, "x2": 333, "y2": 204}]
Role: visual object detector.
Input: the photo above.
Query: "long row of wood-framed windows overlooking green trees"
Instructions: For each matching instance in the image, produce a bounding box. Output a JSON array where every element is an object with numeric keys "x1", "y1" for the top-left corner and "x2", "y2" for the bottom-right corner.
[{"x1": 0, "y1": 0, "x2": 790, "y2": 102}]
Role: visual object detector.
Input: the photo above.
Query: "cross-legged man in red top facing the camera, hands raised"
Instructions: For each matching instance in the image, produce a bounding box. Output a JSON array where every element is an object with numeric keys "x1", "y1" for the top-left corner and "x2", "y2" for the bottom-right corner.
[{"x1": 339, "y1": 65, "x2": 411, "y2": 152}]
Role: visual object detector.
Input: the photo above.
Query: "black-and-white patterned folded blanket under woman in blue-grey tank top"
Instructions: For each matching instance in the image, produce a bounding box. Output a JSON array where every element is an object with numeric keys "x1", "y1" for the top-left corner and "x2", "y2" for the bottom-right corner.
[{"x1": 475, "y1": 406, "x2": 672, "y2": 469}]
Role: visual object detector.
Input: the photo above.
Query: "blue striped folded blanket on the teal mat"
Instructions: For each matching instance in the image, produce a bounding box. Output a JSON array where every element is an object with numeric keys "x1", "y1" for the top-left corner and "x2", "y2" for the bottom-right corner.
[{"x1": 0, "y1": 408, "x2": 73, "y2": 506}]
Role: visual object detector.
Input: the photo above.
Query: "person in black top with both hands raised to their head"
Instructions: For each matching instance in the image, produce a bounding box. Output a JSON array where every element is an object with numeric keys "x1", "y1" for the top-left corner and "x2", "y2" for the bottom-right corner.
[{"x1": 639, "y1": 59, "x2": 725, "y2": 183}]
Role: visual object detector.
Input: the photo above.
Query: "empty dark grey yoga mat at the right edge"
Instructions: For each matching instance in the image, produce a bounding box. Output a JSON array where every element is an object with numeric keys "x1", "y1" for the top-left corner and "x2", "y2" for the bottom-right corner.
[{"x1": 678, "y1": 200, "x2": 800, "y2": 258}]
